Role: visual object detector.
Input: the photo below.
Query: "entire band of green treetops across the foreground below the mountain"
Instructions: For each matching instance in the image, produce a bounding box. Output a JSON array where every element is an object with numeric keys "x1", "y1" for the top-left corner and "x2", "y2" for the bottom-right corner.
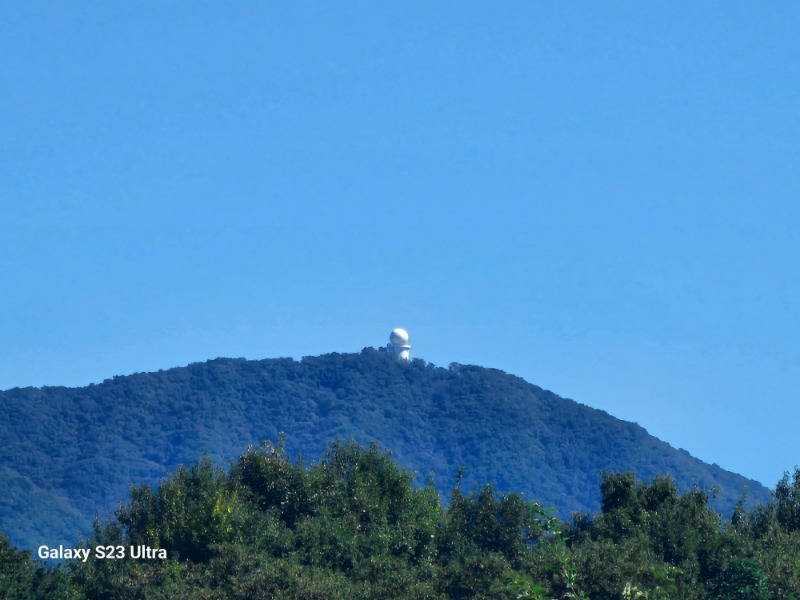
[{"x1": 0, "y1": 441, "x2": 800, "y2": 600}]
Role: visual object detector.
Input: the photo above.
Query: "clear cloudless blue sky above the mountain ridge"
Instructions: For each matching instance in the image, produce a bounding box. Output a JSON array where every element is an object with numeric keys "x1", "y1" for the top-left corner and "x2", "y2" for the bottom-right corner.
[{"x1": 0, "y1": 1, "x2": 800, "y2": 486}]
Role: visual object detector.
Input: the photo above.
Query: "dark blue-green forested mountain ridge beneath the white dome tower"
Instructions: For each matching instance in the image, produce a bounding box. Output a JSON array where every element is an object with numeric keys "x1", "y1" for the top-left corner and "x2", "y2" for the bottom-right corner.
[{"x1": 0, "y1": 348, "x2": 769, "y2": 548}]
